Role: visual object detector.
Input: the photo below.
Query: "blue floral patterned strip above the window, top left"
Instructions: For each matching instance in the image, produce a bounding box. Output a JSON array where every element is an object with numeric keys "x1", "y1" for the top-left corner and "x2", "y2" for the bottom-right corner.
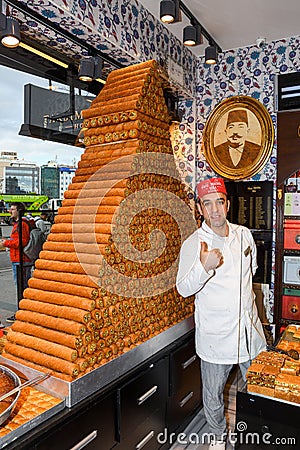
[{"x1": 20, "y1": 0, "x2": 196, "y2": 87}]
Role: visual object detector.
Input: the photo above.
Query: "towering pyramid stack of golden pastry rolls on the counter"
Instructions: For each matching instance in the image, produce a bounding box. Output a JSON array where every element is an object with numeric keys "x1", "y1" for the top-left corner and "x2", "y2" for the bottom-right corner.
[{"x1": 4, "y1": 61, "x2": 193, "y2": 381}]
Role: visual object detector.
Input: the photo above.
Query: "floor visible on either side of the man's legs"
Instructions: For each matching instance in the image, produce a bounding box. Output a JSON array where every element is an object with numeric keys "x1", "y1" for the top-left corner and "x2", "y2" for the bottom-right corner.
[{"x1": 170, "y1": 369, "x2": 243, "y2": 450}]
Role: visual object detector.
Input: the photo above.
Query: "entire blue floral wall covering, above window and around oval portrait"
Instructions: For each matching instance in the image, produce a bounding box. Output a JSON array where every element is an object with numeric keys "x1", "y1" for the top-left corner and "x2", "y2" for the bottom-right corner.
[{"x1": 19, "y1": 0, "x2": 300, "y2": 186}]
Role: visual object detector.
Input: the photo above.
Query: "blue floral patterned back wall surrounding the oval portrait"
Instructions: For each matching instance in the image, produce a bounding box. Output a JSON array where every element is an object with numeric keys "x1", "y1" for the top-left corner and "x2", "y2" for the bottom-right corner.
[{"x1": 196, "y1": 37, "x2": 300, "y2": 185}]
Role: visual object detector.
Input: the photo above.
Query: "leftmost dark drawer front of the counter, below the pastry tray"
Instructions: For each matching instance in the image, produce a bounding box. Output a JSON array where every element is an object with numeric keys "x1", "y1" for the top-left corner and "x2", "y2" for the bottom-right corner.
[{"x1": 32, "y1": 395, "x2": 116, "y2": 450}]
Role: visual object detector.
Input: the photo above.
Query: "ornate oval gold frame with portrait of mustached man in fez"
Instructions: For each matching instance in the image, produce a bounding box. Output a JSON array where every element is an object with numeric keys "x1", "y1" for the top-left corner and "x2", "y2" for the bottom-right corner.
[{"x1": 203, "y1": 95, "x2": 274, "y2": 180}]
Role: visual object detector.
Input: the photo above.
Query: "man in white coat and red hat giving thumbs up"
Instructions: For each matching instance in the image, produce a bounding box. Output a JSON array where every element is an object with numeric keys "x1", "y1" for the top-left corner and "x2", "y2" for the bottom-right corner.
[{"x1": 176, "y1": 178, "x2": 266, "y2": 450}]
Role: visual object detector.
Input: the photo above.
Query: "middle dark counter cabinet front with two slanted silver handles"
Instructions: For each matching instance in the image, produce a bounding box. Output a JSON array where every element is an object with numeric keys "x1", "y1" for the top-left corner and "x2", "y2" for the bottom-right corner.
[{"x1": 118, "y1": 357, "x2": 169, "y2": 450}]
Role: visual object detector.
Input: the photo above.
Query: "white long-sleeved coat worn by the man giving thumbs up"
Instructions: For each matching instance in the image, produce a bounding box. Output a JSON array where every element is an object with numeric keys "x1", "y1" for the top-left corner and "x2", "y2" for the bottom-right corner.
[{"x1": 176, "y1": 222, "x2": 266, "y2": 364}]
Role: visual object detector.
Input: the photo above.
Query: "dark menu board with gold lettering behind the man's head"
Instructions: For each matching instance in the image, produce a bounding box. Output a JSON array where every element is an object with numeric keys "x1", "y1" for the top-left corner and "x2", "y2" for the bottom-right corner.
[{"x1": 226, "y1": 181, "x2": 273, "y2": 230}]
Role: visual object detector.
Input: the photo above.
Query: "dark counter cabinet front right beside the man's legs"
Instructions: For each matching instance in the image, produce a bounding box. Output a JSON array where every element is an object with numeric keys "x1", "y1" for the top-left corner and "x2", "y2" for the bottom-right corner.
[{"x1": 167, "y1": 338, "x2": 201, "y2": 431}]
